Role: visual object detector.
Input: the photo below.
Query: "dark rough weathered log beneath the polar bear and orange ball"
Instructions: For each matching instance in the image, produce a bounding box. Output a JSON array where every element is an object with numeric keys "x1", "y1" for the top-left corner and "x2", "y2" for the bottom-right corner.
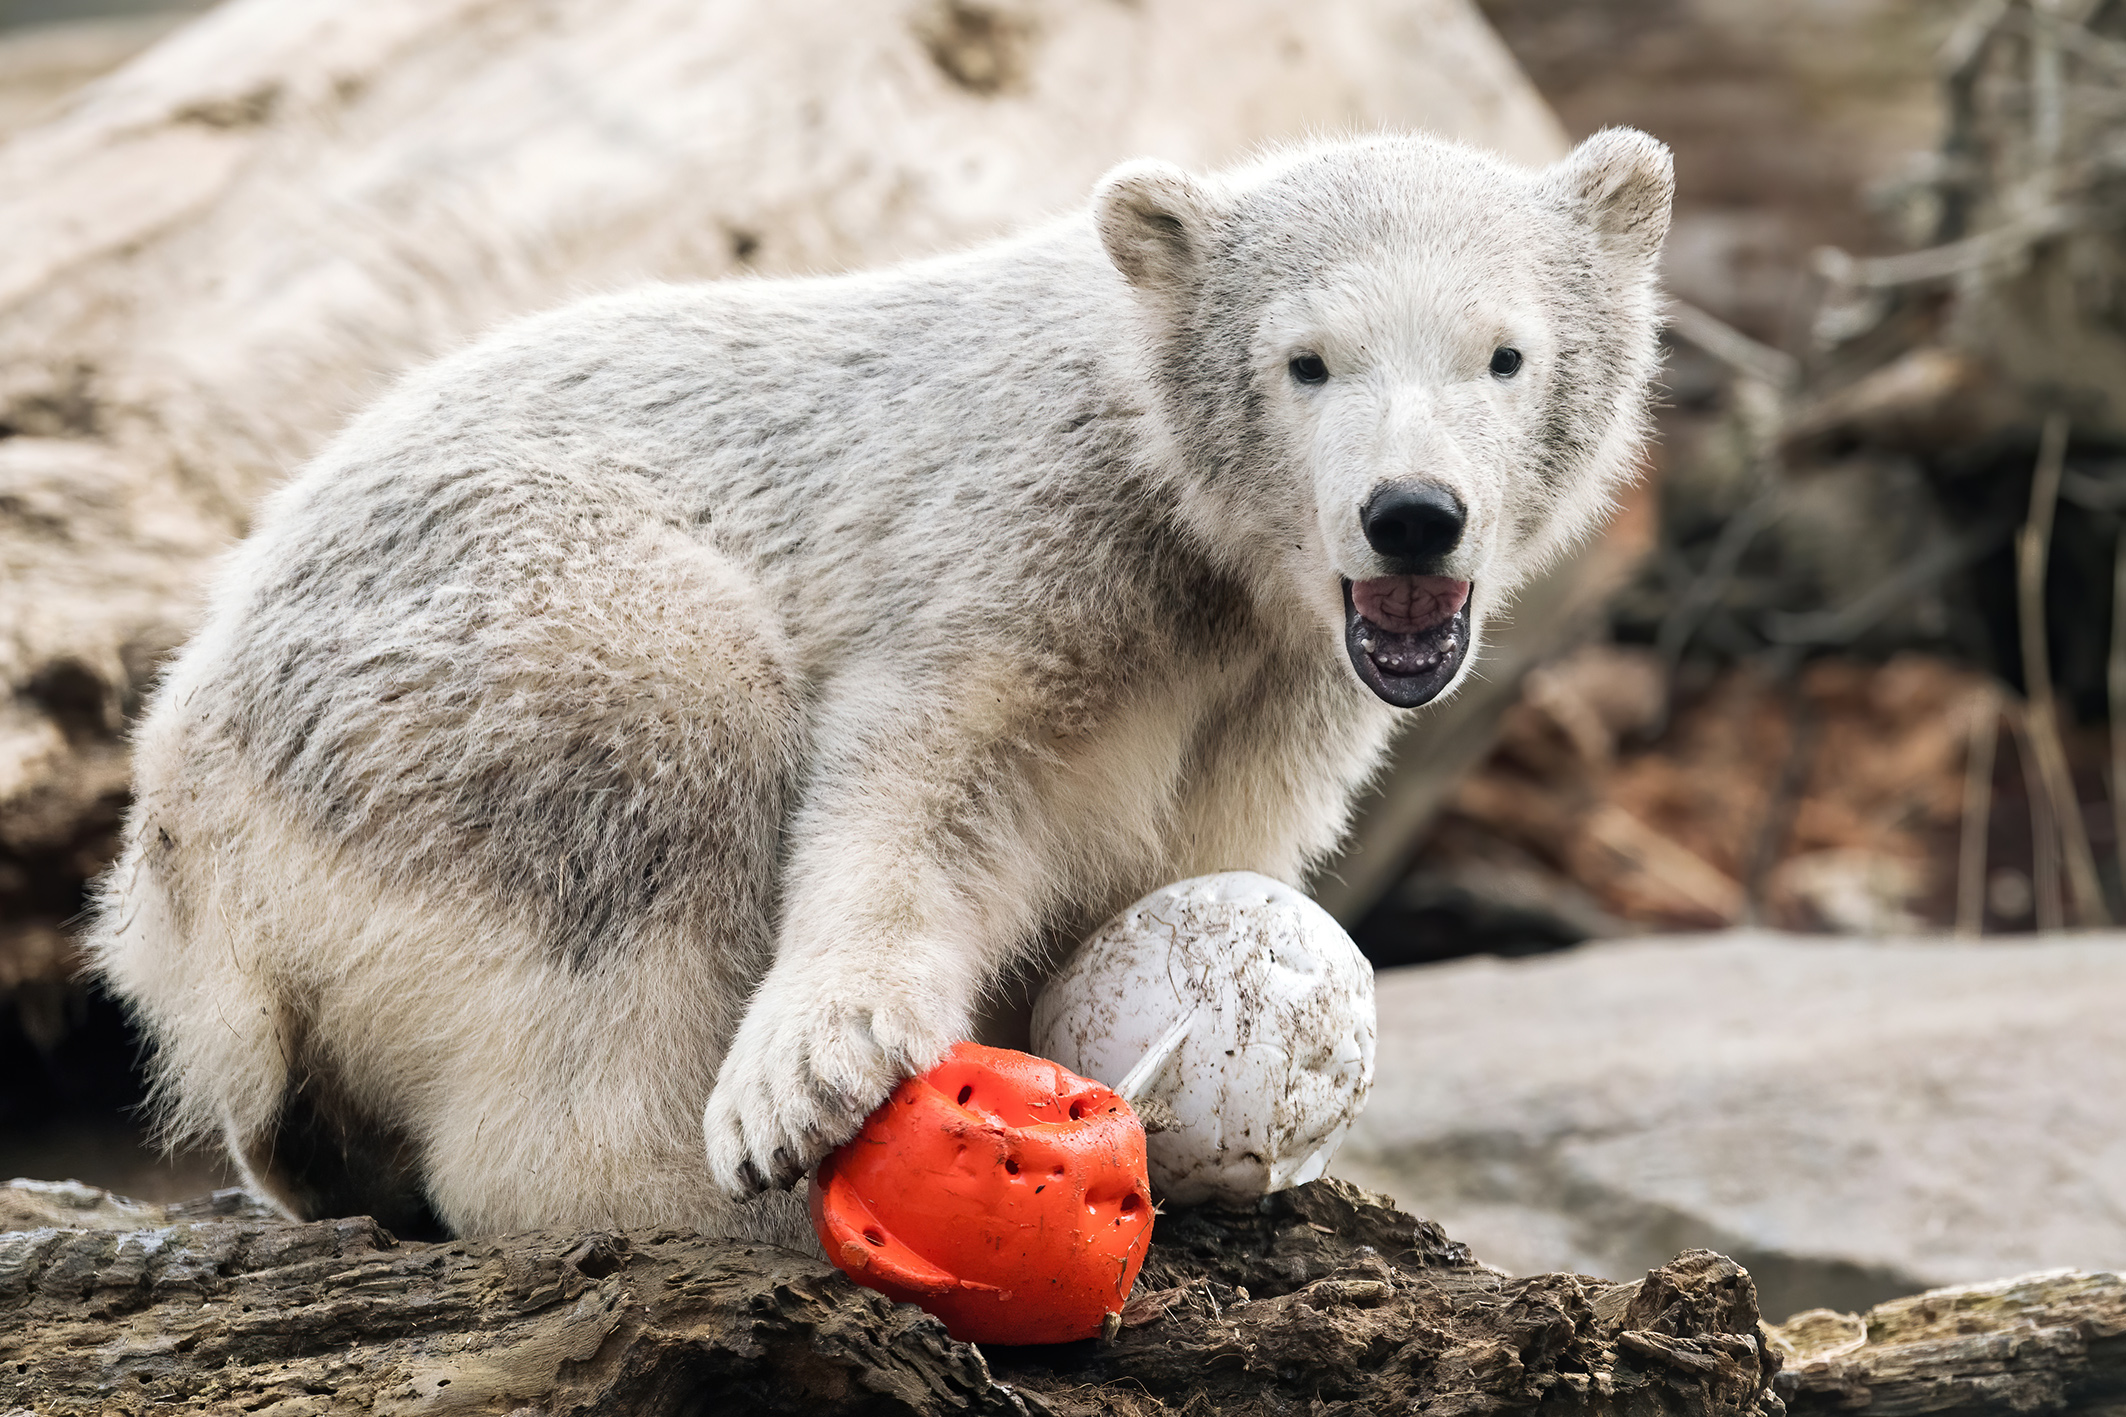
[{"x1": 0, "y1": 1181, "x2": 1777, "y2": 1417}]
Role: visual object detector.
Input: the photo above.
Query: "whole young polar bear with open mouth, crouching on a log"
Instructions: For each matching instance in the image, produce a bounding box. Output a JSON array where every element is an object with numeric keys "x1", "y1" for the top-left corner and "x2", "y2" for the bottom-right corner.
[{"x1": 89, "y1": 130, "x2": 1671, "y2": 1236}]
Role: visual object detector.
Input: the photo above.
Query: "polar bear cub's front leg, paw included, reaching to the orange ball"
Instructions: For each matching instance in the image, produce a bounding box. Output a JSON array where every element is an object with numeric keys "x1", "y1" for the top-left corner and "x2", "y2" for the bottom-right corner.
[{"x1": 704, "y1": 667, "x2": 1072, "y2": 1196}]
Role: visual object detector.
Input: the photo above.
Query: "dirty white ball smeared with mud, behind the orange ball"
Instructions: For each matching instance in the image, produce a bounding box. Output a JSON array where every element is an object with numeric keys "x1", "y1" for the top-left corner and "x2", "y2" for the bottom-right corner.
[{"x1": 1033, "y1": 871, "x2": 1373, "y2": 1202}]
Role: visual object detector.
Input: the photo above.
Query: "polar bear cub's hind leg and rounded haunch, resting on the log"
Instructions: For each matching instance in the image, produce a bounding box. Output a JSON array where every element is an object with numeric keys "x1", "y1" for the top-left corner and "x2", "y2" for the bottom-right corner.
[{"x1": 91, "y1": 516, "x2": 802, "y2": 1232}]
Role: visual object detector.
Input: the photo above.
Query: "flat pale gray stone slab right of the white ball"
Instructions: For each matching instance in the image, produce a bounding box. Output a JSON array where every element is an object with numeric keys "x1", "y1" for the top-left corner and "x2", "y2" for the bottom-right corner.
[{"x1": 1333, "y1": 933, "x2": 2126, "y2": 1319}]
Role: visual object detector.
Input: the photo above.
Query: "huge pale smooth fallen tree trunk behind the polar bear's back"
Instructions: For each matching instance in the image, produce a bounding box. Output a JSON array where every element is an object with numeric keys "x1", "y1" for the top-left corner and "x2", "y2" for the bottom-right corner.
[{"x1": 0, "y1": 0, "x2": 1575, "y2": 988}]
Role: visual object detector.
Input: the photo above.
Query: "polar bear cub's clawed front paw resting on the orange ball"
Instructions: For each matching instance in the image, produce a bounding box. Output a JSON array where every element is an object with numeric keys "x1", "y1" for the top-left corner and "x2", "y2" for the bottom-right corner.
[{"x1": 702, "y1": 994, "x2": 959, "y2": 1196}]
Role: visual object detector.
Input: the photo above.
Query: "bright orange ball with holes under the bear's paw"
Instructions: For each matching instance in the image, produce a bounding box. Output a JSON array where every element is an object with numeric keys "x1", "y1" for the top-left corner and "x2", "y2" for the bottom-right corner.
[{"x1": 810, "y1": 1043, "x2": 1152, "y2": 1343}]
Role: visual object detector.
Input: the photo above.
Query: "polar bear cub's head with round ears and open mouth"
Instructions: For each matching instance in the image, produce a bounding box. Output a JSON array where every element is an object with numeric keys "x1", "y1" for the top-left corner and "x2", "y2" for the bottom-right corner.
[{"x1": 1093, "y1": 127, "x2": 1673, "y2": 707}]
